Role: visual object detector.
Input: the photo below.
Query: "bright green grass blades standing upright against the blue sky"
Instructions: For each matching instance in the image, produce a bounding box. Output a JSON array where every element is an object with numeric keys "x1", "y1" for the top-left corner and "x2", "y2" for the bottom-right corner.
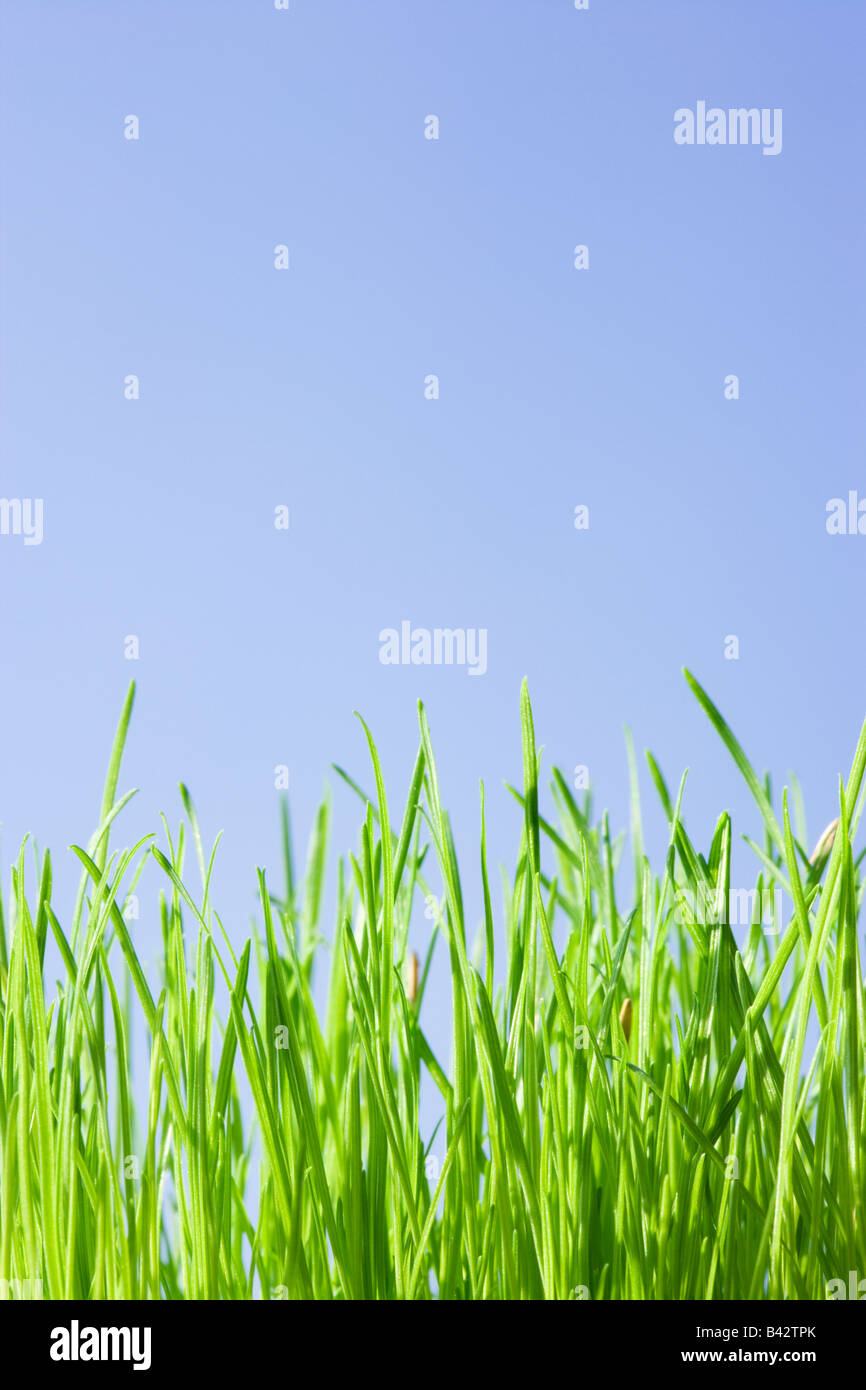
[{"x1": 0, "y1": 677, "x2": 866, "y2": 1300}]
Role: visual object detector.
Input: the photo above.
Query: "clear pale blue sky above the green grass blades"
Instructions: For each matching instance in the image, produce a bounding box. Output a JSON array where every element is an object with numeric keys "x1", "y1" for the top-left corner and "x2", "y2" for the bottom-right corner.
[{"x1": 0, "y1": 0, "x2": 866, "y2": 1067}]
